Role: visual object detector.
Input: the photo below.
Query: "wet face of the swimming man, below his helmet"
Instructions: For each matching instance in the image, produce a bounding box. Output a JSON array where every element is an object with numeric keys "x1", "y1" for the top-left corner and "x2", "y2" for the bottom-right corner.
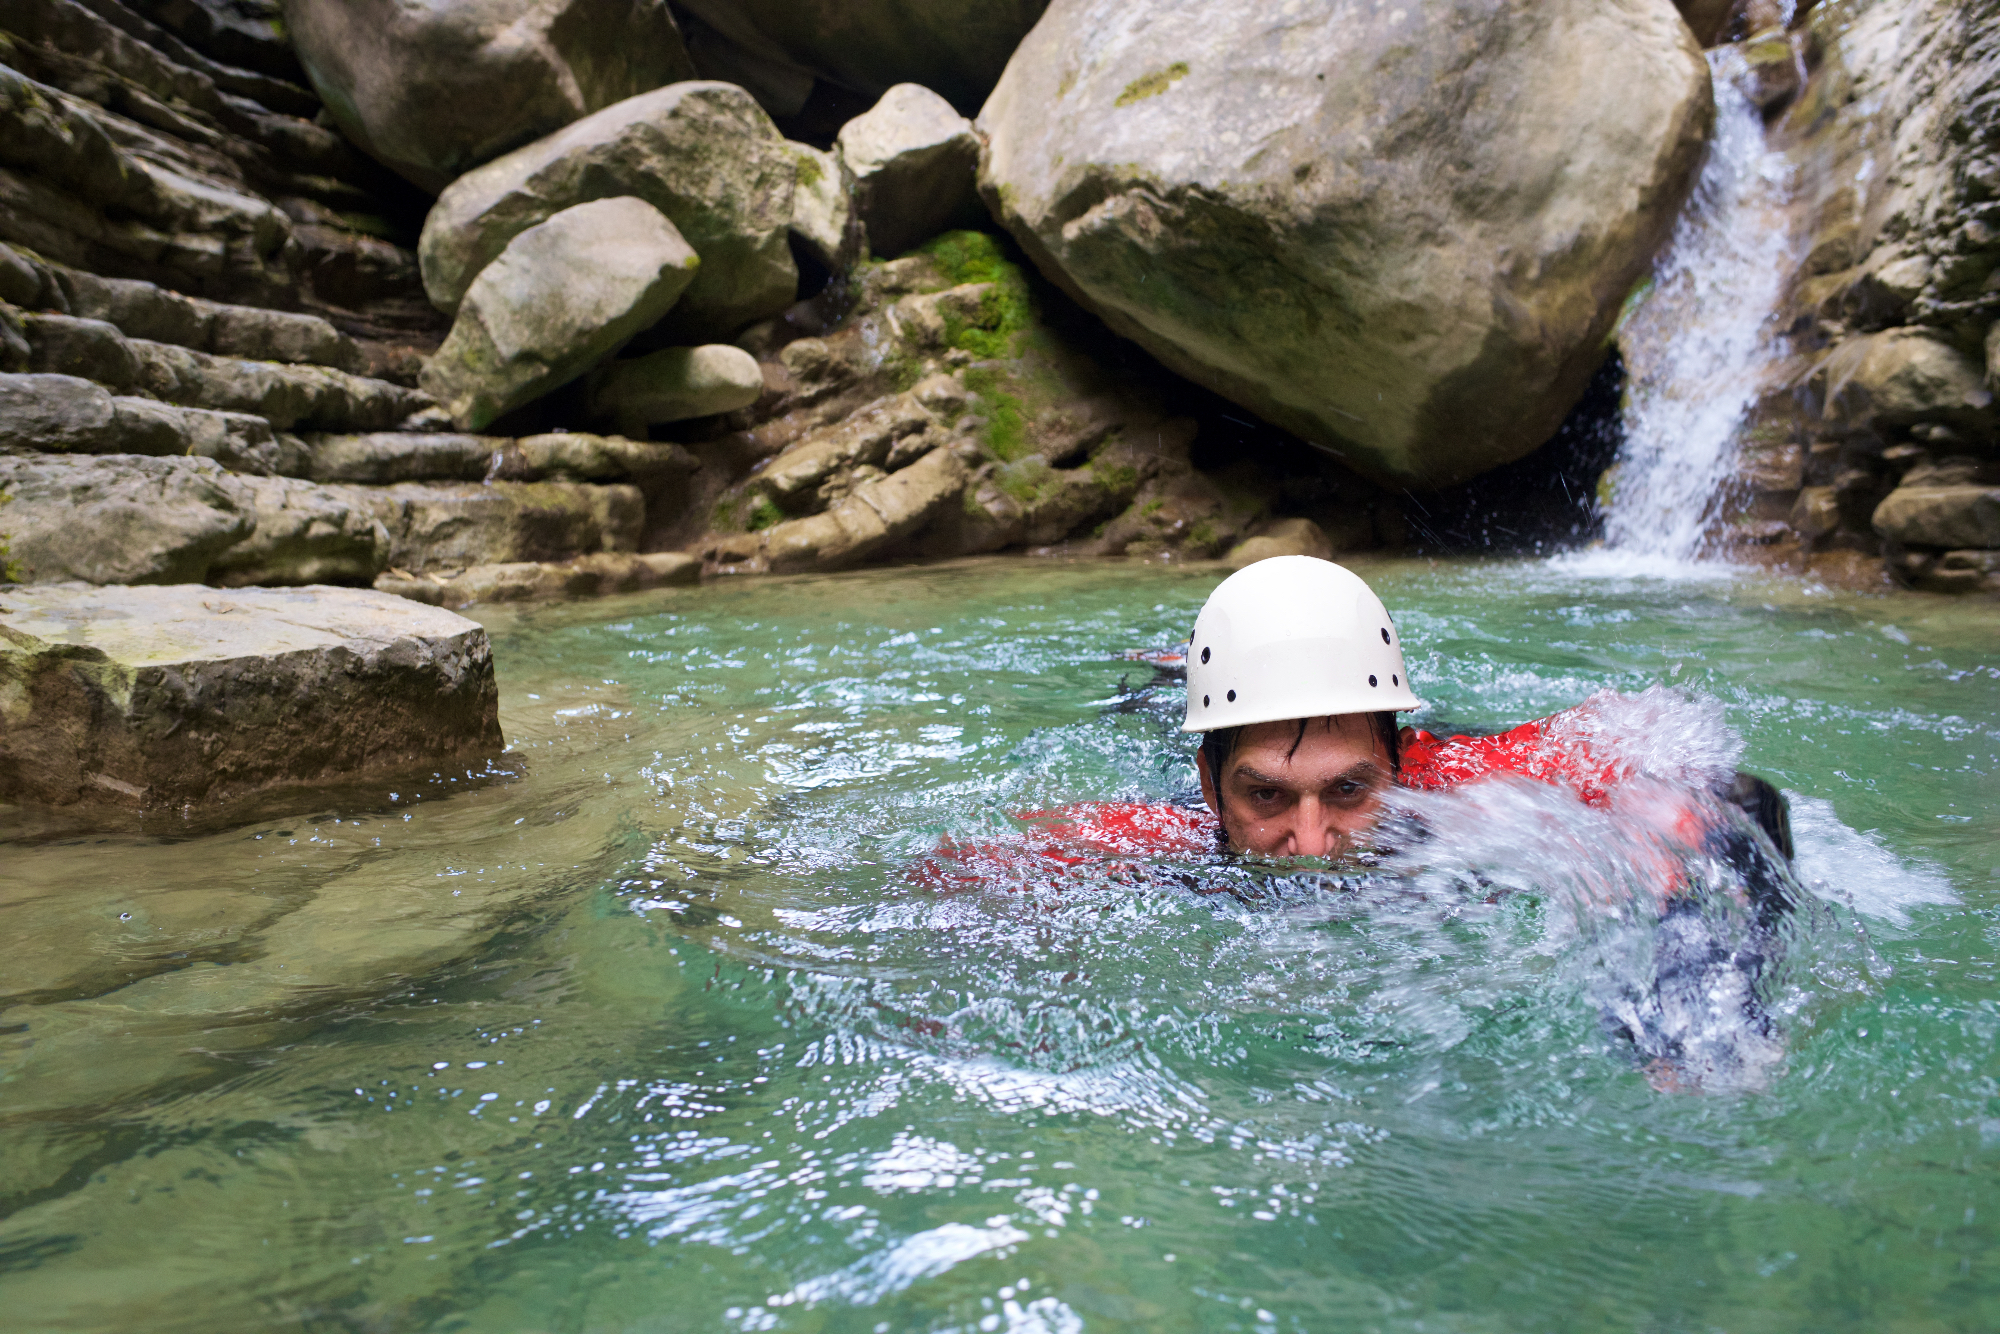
[{"x1": 1196, "y1": 714, "x2": 1392, "y2": 856}]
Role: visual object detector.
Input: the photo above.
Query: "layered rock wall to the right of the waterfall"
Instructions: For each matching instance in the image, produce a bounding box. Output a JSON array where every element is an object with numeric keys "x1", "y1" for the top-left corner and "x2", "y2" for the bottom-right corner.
[{"x1": 1732, "y1": 0, "x2": 2000, "y2": 592}]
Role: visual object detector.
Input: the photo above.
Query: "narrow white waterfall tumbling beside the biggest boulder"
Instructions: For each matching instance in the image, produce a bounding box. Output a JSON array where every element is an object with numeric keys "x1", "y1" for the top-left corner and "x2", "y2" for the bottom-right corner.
[{"x1": 1564, "y1": 46, "x2": 1798, "y2": 574}]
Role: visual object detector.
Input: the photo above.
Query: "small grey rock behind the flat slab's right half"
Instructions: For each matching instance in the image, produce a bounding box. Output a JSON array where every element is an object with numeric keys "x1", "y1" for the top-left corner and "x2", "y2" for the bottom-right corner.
[{"x1": 208, "y1": 478, "x2": 390, "y2": 588}]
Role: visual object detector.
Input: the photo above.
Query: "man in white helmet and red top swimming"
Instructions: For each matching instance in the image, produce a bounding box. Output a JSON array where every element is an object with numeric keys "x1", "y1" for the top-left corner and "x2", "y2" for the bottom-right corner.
[{"x1": 924, "y1": 556, "x2": 1792, "y2": 922}]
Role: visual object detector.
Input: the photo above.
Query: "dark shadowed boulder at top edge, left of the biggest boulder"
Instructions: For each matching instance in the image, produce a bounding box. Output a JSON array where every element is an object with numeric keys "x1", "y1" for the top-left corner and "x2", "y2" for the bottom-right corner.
[{"x1": 680, "y1": 0, "x2": 1048, "y2": 116}]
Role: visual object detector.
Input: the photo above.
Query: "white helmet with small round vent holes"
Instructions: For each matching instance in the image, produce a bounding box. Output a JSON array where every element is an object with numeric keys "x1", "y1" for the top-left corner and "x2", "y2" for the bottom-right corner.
[{"x1": 1180, "y1": 556, "x2": 1422, "y2": 732}]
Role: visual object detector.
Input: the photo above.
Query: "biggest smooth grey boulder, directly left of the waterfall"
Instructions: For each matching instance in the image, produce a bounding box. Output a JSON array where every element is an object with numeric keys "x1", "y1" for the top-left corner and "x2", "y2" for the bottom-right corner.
[{"x1": 980, "y1": 0, "x2": 1714, "y2": 486}]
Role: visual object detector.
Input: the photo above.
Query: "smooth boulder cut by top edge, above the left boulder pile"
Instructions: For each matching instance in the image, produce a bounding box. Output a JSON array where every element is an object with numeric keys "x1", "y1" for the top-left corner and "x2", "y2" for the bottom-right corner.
[{"x1": 284, "y1": 0, "x2": 694, "y2": 194}]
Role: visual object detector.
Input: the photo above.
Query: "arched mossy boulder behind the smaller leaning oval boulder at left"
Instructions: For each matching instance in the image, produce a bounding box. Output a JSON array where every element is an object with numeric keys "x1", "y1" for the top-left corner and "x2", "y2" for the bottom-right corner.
[{"x1": 418, "y1": 82, "x2": 798, "y2": 342}]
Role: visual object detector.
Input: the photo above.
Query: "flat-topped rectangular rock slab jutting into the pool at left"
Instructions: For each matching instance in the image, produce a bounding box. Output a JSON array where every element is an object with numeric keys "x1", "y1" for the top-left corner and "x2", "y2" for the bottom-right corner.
[{"x1": 0, "y1": 584, "x2": 506, "y2": 810}]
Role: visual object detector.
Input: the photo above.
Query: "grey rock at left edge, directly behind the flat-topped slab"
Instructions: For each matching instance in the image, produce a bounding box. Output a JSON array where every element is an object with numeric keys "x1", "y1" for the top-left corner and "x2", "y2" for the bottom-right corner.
[{"x1": 0, "y1": 454, "x2": 256, "y2": 584}]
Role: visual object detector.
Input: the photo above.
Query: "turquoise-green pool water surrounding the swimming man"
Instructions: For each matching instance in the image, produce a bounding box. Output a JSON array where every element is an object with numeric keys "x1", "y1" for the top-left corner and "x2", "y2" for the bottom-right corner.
[{"x1": 0, "y1": 560, "x2": 2000, "y2": 1332}]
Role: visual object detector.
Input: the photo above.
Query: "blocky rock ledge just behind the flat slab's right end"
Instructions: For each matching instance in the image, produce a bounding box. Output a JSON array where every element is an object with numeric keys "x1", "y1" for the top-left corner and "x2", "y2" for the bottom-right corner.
[{"x1": 352, "y1": 482, "x2": 646, "y2": 574}]
